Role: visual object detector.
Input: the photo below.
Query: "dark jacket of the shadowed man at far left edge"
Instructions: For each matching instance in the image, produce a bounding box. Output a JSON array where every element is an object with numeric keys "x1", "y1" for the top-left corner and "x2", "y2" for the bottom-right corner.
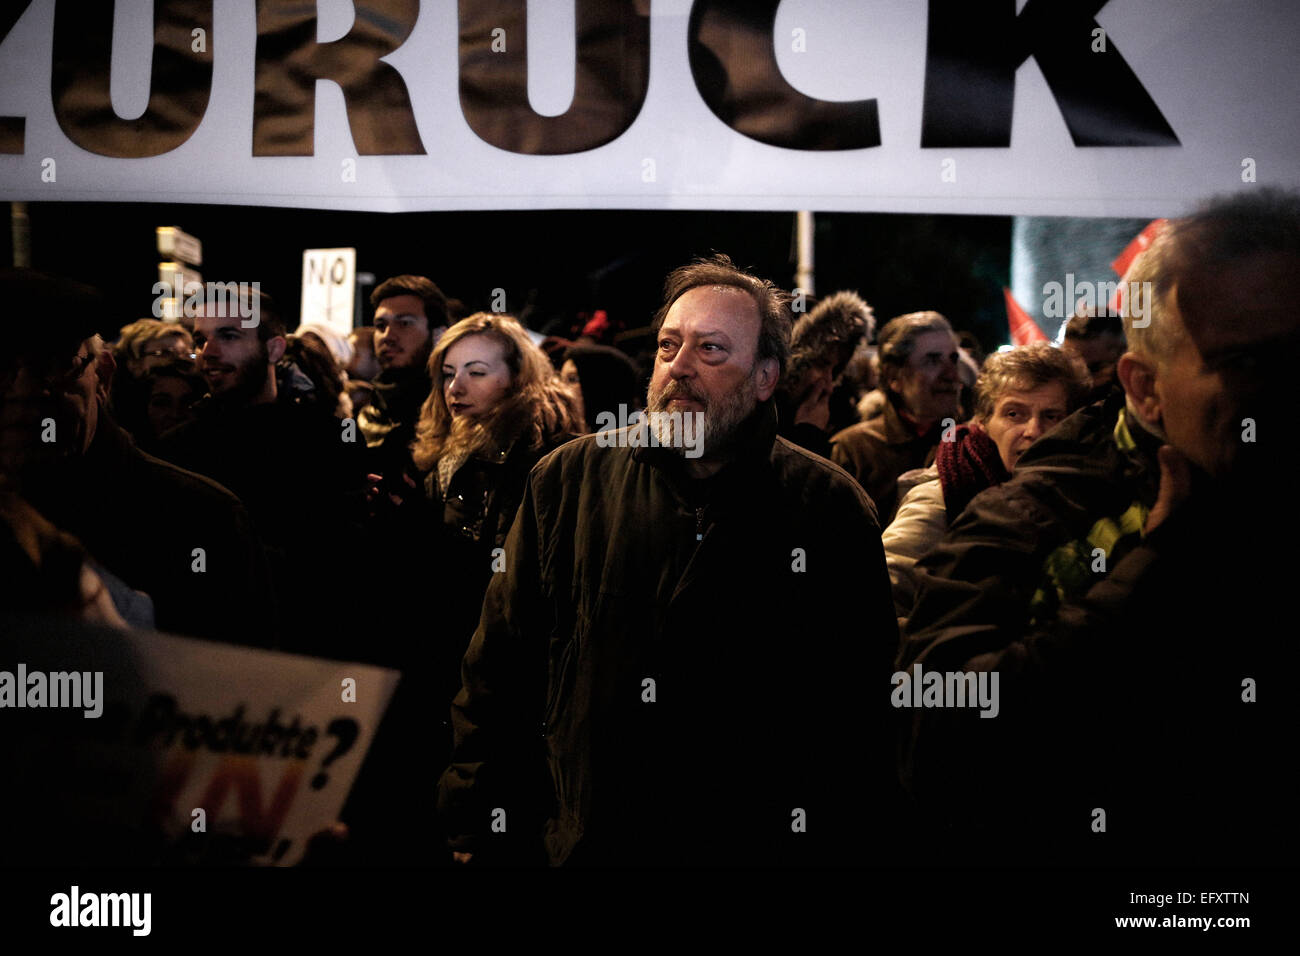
[{"x1": 23, "y1": 410, "x2": 274, "y2": 646}]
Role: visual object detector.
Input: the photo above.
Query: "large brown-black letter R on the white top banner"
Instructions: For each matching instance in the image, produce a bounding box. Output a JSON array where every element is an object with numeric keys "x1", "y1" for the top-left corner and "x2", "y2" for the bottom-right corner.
[{"x1": 252, "y1": 0, "x2": 424, "y2": 156}]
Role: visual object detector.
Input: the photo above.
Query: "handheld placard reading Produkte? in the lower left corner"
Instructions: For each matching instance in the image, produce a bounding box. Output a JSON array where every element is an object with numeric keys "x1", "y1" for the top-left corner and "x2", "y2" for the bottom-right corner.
[{"x1": 0, "y1": 623, "x2": 399, "y2": 865}]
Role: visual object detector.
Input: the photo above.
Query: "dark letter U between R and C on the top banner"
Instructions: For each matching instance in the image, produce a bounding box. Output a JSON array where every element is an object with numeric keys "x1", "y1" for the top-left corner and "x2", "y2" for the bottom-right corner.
[{"x1": 460, "y1": 0, "x2": 650, "y2": 156}]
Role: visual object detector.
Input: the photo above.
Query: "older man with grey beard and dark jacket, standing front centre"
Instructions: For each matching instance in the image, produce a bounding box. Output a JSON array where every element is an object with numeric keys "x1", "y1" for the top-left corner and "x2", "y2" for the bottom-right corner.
[{"x1": 439, "y1": 256, "x2": 896, "y2": 866}]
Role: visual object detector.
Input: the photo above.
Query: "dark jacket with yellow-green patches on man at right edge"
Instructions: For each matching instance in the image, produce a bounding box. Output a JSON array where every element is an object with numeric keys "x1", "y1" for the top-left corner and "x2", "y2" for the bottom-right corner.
[{"x1": 898, "y1": 395, "x2": 1297, "y2": 865}]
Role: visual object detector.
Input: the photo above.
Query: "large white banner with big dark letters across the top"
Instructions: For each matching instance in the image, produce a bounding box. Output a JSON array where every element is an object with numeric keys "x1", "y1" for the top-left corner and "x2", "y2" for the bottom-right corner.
[{"x1": 0, "y1": 0, "x2": 1300, "y2": 216}]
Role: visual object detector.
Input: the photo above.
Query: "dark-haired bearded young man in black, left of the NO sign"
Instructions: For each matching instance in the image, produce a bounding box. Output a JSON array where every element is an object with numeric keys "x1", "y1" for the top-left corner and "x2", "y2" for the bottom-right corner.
[{"x1": 160, "y1": 290, "x2": 364, "y2": 657}]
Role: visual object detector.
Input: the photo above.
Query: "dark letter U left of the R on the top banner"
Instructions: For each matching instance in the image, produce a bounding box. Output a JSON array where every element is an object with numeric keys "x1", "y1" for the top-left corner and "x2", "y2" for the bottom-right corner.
[{"x1": 51, "y1": 0, "x2": 212, "y2": 159}]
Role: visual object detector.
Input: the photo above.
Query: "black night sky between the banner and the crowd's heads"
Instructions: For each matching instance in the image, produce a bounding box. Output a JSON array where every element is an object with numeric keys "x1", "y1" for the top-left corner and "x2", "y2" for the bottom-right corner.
[{"x1": 0, "y1": 203, "x2": 1011, "y2": 349}]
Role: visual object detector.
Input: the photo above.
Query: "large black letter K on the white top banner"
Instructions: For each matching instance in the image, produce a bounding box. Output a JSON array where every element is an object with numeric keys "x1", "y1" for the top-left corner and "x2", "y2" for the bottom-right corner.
[{"x1": 920, "y1": 0, "x2": 1179, "y2": 148}]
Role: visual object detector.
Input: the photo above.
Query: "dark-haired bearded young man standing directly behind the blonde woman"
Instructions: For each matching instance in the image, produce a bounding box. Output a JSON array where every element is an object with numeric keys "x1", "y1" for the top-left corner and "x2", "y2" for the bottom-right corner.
[{"x1": 356, "y1": 276, "x2": 450, "y2": 481}]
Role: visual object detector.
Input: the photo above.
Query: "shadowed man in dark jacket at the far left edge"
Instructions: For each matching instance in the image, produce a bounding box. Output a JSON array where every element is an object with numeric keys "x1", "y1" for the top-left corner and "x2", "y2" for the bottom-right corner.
[{"x1": 0, "y1": 269, "x2": 274, "y2": 644}]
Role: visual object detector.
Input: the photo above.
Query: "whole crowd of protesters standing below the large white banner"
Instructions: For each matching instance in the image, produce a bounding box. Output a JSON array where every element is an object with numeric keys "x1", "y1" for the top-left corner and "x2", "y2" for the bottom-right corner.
[{"x1": 0, "y1": 193, "x2": 1300, "y2": 865}]
